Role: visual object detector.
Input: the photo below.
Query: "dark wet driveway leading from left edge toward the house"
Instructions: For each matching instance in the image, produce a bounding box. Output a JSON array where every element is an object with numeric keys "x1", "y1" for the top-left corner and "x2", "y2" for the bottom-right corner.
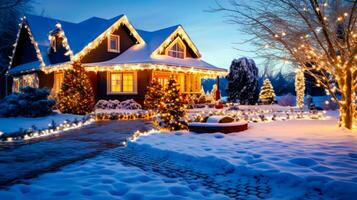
[{"x1": 0, "y1": 120, "x2": 151, "y2": 187}]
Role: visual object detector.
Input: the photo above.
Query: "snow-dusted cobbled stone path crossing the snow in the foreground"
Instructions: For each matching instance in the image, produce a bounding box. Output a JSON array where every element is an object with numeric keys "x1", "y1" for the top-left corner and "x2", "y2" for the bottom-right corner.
[{"x1": 107, "y1": 148, "x2": 271, "y2": 199}]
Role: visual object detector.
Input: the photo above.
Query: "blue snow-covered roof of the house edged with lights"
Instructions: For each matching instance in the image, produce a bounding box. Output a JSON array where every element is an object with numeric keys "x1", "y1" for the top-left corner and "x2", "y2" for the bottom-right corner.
[{"x1": 12, "y1": 15, "x2": 226, "y2": 72}]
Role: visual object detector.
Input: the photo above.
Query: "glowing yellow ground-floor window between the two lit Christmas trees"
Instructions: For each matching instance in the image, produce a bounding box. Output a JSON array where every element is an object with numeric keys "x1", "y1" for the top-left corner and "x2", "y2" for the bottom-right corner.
[{"x1": 108, "y1": 72, "x2": 136, "y2": 94}]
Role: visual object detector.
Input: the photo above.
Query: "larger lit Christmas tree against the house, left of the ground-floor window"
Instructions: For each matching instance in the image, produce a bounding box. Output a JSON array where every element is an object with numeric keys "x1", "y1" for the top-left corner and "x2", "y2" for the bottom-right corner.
[{"x1": 58, "y1": 62, "x2": 95, "y2": 115}]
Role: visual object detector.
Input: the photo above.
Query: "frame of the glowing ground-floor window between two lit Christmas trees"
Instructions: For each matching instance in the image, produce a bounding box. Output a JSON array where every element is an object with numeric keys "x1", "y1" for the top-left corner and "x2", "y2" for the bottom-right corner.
[{"x1": 107, "y1": 71, "x2": 138, "y2": 95}]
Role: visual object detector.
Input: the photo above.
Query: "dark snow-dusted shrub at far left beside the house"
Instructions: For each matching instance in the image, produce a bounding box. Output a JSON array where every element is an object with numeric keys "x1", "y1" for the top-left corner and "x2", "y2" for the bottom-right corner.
[{"x1": 0, "y1": 87, "x2": 55, "y2": 117}]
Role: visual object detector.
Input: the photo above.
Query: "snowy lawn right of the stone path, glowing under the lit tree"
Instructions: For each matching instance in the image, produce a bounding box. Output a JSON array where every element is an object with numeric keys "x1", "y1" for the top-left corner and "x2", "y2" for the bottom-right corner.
[{"x1": 129, "y1": 112, "x2": 357, "y2": 199}]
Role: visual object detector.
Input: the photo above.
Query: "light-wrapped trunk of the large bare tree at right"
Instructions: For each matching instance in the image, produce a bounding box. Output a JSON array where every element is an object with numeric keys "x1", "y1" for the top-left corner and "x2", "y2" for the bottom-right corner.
[{"x1": 340, "y1": 68, "x2": 355, "y2": 129}]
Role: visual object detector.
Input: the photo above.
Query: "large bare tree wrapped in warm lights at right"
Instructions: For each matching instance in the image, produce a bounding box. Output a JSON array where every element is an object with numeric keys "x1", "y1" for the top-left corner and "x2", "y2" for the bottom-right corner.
[{"x1": 215, "y1": 0, "x2": 357, "y2": 129}]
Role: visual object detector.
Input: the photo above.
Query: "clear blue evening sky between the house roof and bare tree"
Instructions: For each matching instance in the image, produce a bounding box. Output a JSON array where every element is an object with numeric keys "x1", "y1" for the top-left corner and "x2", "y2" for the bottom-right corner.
[{"x1": 33, "y1": 0, "x2": 259, "y2": 68}]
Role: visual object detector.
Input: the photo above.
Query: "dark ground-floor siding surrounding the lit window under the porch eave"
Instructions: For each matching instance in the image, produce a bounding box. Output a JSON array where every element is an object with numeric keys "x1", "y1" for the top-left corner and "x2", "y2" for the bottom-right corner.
[{"x1": 97, "y1": 70, "x2": 152, "y2": 104}]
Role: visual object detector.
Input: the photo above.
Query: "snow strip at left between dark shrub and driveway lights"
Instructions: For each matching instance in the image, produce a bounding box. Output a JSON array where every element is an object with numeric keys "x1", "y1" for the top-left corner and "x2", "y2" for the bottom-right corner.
[{"x1": 0, "y1": 112, "x2": 83, "y2": 133}]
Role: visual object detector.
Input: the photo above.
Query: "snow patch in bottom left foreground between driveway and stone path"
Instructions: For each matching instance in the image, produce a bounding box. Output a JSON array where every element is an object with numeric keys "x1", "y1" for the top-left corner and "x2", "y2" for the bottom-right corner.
[{"x1": 0, "y1": 150, "x2": 228, "y2": 200}]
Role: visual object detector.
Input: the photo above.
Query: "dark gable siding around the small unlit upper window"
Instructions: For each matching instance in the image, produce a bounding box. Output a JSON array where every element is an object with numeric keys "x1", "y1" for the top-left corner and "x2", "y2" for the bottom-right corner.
[{"x1": 82, "y1": 25, "x2": 137, "y2": 63}]
